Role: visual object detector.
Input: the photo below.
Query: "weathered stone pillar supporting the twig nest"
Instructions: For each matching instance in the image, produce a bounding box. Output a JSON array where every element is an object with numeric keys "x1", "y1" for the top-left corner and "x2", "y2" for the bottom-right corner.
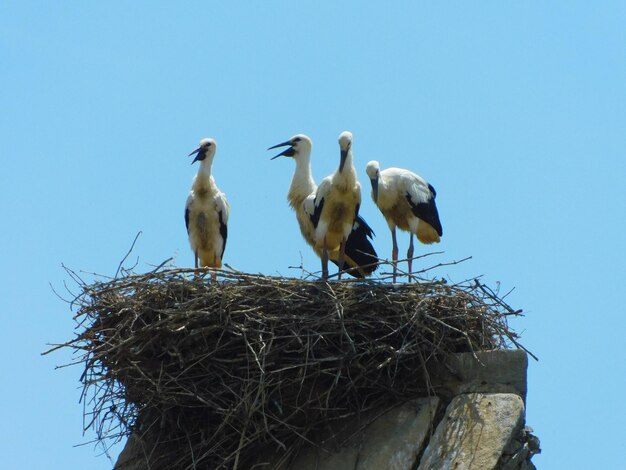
[{"x1": 115, "y1": 350, "x2": 541, "y2": 470}]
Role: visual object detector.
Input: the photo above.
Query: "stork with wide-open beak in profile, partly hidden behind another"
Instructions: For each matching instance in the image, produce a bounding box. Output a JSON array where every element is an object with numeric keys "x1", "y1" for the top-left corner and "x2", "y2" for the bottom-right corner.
[{"x1": 268, "y1": 134, "x2": 378, "y2": 278}]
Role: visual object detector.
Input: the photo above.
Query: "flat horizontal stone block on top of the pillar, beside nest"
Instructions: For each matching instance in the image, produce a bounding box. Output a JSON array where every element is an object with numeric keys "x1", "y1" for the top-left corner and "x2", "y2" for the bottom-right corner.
[{"x1": 430, "y1": 350, "x2": 528, "y2": 401}]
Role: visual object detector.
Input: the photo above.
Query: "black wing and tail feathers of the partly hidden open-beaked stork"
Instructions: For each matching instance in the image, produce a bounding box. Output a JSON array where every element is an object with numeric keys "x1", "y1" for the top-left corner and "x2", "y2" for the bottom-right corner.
[{"x1": 333, "y1": 216, "x2": 378, "y2": 278}]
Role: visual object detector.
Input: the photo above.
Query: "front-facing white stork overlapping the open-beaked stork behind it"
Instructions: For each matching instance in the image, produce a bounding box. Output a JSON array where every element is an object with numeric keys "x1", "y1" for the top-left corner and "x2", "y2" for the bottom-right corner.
[{"x1": 311, "y1": 131, "x2": 361, "y2": 279}]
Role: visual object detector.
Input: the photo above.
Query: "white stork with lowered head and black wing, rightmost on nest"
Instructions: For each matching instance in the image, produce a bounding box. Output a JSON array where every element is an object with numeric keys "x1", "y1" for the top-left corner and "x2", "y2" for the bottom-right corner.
[{"x1": 366, "y1": 161, "x2": 443, "y2": 282}]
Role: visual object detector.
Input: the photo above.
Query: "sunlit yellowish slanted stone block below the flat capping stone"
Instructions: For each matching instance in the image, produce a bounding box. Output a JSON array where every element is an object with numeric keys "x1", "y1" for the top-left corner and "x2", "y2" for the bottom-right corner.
[{"x1": 418, "y1": 393, "x2": 524, "y2": 470}]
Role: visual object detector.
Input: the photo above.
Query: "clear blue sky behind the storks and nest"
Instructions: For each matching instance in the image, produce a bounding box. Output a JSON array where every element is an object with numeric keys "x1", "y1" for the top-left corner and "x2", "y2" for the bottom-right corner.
[{"x1": 0, "y1": 0, "x2": 626, "y2": 469}]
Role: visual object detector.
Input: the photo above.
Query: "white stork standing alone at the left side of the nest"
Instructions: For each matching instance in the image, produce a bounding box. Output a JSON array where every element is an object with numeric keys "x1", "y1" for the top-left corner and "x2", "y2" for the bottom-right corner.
[{"x1": 185, "y1": 139, "x2": 230, "y2": 270}]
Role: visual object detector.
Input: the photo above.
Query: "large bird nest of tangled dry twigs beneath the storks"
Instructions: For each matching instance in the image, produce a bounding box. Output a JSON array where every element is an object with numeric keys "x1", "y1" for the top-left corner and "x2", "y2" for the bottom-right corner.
[{"x1": 54, "y1": 267, "x2": 521, "y2": 469}]
